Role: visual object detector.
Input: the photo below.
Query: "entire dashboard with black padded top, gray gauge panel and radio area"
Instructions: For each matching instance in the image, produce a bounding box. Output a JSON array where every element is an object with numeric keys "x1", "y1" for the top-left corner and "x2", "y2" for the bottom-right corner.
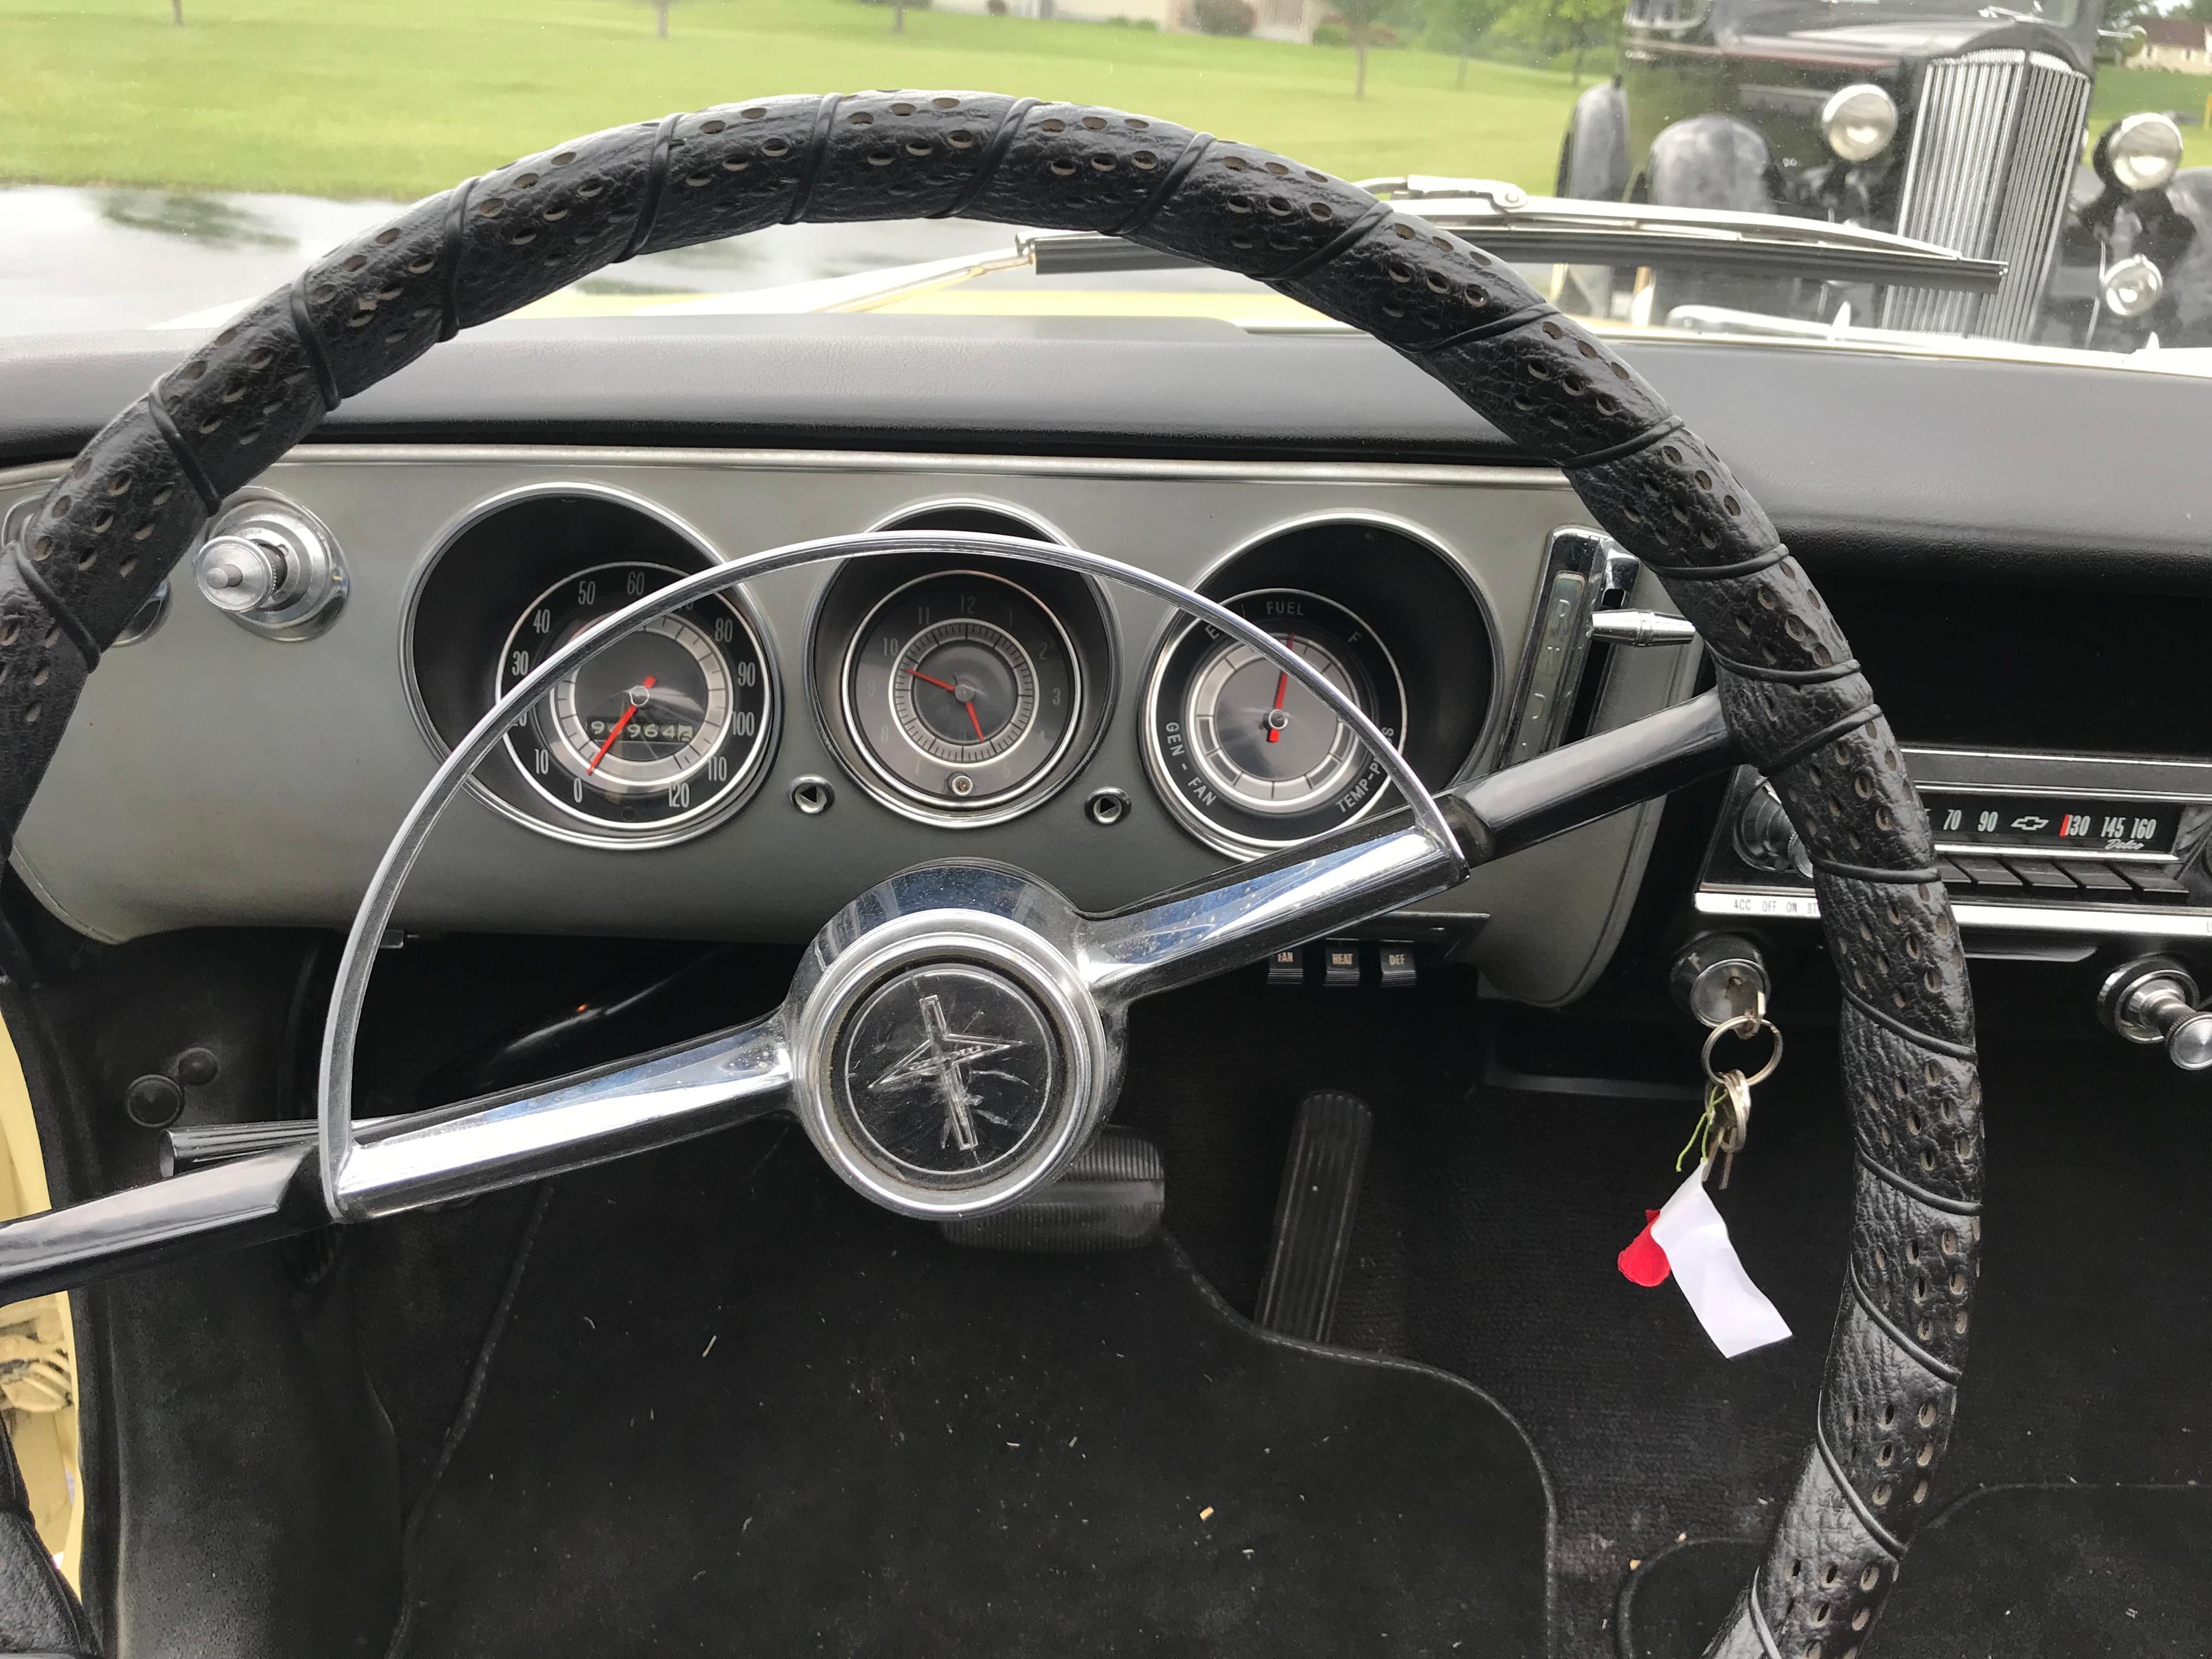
[{"x1": 0, "y1": 316, "x2": 2212, "y2": 1004}]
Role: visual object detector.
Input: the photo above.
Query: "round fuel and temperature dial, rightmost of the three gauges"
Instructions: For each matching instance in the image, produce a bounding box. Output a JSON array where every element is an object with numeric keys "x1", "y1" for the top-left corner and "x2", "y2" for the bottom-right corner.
[{"x1": 1146, "y1": 588, "x2": 1407, "y2": 854}]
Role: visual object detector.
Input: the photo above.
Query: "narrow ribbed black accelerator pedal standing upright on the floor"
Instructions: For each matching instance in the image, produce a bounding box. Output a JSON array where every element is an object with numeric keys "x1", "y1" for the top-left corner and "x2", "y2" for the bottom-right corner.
[{"x1": 1254, "y1": 1088, "x2": 1374, "y2": 1343}]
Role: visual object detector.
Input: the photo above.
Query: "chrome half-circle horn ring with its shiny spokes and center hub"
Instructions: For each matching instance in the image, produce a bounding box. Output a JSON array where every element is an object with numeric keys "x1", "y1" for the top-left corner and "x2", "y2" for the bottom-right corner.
[{"x1": 316, "y1": 531, "x2": 1464, "y2": 1221}]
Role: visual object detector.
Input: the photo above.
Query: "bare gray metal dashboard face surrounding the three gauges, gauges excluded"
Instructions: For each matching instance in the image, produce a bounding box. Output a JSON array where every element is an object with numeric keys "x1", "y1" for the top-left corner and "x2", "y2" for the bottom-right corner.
[{"x1": 0, "y1": 445, "x2": 1692, "y2": 1002}]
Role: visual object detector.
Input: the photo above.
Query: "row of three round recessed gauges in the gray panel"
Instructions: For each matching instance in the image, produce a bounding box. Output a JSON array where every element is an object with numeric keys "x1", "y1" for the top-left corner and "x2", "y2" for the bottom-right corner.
[{"x1": 405, "y1": 487, "x2": 1498, "y2": 858}]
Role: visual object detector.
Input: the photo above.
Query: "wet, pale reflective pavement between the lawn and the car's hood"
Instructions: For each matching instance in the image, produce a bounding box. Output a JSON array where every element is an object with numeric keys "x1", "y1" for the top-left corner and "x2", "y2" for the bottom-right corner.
[{"x1": 0, "y1": 186, "x2": 1013, "y2": 334}]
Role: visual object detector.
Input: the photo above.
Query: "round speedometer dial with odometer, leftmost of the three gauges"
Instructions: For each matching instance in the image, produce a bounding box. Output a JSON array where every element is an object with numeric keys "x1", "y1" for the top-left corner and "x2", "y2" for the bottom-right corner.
[{"x1": 498, "y1": 562, "x2": 774, "y2": 838}]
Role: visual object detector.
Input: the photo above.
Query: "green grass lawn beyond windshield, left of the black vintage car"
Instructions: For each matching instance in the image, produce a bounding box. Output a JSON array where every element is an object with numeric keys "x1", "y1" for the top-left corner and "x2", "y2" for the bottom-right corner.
[{"x1": 0, "y1": 0, "x2": 1573, "y2": 199}]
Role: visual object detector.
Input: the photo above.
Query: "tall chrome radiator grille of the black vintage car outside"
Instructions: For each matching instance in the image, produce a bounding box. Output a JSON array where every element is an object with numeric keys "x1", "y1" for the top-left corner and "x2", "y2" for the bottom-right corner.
[{"x1": 1883, "y1": 51, "x2": 2090, "y2": 340}]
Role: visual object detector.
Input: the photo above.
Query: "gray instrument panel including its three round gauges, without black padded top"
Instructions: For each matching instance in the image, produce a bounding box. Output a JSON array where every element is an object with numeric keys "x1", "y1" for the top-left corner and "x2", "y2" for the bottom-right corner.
[{"x1": 0, "y1": 445, "x2": 1696, "y2": 1000}]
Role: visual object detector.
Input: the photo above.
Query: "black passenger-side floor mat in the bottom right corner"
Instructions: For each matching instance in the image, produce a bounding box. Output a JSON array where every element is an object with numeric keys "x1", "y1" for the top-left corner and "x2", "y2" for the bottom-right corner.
[{"x1": 1619, "y1": 1486, "x2": 2212, "y2": 1659}]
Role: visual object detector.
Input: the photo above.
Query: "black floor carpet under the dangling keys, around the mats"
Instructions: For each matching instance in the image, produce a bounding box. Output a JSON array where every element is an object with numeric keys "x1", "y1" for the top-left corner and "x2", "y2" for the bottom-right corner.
[{"x1": 1117, "y1": 962, "x2": 2212, "y2": 1659}]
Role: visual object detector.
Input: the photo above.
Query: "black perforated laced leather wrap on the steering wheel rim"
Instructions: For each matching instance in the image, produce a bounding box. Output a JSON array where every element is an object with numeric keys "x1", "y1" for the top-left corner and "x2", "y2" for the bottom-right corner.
[{"x1": 0, "y1": 93, "x2": 1982, "y2": 1659}]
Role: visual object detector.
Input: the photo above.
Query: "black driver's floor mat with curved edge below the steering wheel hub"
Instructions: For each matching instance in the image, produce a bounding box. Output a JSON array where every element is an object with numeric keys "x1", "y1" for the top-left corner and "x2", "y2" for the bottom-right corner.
[{"x1": 389, "y1": 1126, "x2": 1553, "y2": 1659}]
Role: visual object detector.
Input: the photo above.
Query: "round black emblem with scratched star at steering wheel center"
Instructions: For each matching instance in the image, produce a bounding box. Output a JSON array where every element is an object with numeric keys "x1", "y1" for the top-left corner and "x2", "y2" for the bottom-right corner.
[{"x1": 830, "y1": 962, "x2": 1062, "y2": 1185}]
